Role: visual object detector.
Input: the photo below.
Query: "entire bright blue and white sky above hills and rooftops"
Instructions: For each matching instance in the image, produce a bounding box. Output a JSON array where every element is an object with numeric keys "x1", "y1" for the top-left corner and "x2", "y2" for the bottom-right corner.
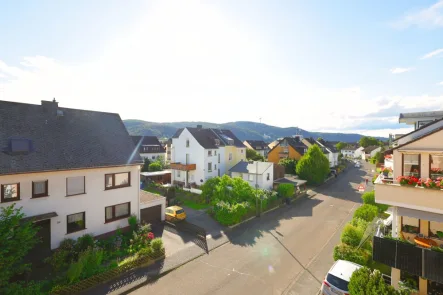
[{"x1": 0, "y1": 0, "x2": 443, "y2": 136}]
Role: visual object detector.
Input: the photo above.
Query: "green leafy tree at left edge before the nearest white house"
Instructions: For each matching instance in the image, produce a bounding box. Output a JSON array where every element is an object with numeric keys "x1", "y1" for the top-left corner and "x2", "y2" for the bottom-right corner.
[{"x1": 0, "y1": 204, "x2": 39, "y2": 290}]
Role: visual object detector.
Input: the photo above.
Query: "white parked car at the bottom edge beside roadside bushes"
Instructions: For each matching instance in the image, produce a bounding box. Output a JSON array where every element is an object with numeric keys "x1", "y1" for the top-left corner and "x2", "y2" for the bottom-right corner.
[{"x1": 321, "y1": 260, "x2": 362, "y2": 295}]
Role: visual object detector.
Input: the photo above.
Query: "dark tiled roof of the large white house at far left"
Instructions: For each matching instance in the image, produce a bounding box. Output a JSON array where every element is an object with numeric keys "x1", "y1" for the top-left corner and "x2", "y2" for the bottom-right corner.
[{"x1": 0, "y1": 101, "x2": 142, "y2": 174}]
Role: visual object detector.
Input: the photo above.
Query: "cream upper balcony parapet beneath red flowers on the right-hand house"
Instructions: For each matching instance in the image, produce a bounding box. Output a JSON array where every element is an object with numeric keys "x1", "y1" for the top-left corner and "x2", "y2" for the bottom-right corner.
[{"x1": 375, "y1": 179, "x2": 443, "y2": 214}]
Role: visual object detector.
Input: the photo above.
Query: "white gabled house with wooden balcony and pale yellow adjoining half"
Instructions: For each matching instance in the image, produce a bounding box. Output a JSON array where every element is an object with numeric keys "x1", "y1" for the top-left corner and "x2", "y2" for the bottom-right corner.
[{"x1": 171, "y1": 125, "x2": 246, "y2": 186}]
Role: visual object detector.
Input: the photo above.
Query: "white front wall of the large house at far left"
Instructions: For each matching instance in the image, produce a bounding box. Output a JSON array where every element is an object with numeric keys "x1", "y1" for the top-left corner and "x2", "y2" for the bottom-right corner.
[{"x1": 0, "y1": 166, "x2": 140, "y2": 249}]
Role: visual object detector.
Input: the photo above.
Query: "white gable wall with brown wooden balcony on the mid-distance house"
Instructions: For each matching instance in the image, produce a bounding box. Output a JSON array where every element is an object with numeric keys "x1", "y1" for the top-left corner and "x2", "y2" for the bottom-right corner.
[{"x1": 171, "y1": 128, "x2": 205, "y2": 185}]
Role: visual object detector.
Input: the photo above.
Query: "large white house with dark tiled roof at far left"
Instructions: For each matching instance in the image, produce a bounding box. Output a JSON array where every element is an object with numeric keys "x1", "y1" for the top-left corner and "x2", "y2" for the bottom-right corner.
[{"x1": 0, "y1": 100, "x2": 142, "y2": 252}]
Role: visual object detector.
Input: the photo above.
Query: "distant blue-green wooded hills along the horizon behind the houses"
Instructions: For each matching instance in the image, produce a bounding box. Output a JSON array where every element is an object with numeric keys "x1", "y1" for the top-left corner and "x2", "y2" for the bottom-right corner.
[{"x1": 123, "y1": 120, "x2": 386, "y2": 142}]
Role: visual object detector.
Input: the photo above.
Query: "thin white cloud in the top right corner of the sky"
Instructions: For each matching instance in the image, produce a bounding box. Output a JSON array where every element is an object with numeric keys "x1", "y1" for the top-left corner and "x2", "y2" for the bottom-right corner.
[{"x1": 393, "y1": 0, "x2": 443, "y2": 28}]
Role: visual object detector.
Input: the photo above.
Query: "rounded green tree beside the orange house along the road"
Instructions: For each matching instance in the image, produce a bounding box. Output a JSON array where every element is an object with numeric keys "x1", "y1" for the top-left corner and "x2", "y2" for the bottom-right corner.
[{"x1": 296, "y1": 144, "x2": 329, "y2": 184}]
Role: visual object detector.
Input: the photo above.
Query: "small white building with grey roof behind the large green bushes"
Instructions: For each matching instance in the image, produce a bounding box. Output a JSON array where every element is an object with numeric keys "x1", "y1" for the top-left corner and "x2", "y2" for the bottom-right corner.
[{"x1": 229, "y1": 161, "x2": 274, "y2": 190}]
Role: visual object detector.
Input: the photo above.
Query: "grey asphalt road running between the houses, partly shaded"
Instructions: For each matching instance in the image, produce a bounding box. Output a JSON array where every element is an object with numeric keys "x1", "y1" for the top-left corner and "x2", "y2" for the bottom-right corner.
[{"x1": 130, "y1": 163, "x2": 371, "y2": 295}]
